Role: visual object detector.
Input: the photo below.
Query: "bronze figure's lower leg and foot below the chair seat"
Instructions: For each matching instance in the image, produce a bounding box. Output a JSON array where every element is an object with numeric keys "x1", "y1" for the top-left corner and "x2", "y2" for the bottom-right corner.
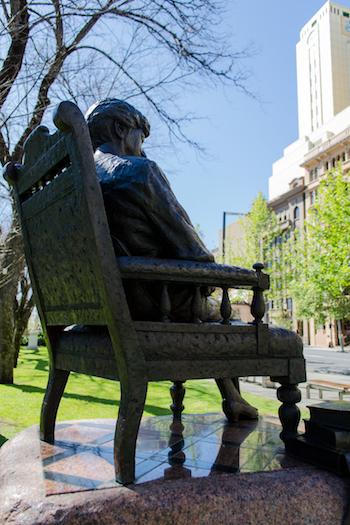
[{"x1": 215, "y1": 377, "x2": 258, "y2": 421}]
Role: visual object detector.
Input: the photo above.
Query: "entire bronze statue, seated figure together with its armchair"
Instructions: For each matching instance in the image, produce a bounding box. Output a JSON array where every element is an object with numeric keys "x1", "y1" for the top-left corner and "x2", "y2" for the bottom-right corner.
[{"x1": 5, "y1": 99, "x2": 305, "y2": 484}]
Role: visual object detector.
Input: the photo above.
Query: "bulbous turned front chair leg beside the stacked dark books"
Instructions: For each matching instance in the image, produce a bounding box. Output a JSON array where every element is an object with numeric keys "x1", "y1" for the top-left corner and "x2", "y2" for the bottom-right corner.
[{"x1": 277, "y1": 383, "x2": 301, "y2": 441}]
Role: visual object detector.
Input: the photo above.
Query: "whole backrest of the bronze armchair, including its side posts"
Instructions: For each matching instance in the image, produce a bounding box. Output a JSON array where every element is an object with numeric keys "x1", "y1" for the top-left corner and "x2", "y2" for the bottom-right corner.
[{"x1": 8, "y1": 102, "x2": 131, "y2": 338}]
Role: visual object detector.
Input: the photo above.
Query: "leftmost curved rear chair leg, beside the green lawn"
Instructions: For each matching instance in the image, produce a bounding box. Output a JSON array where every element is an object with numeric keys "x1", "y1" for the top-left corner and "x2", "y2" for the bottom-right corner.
[{"x1": 40, "y1": 367, "x2": 69, "y2": 443}]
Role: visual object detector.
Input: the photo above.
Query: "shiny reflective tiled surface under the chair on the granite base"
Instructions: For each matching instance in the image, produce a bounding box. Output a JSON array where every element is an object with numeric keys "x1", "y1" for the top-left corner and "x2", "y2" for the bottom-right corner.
[{"x1": 41, "y1": 414, "x2": 305, "y2": 495}]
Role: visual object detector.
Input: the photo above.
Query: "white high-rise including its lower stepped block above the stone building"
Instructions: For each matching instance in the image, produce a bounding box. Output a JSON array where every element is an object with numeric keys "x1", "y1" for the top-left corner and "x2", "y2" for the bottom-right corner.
[{"x1": 269, "y1": 1, "x2": 350, "y2": 200}]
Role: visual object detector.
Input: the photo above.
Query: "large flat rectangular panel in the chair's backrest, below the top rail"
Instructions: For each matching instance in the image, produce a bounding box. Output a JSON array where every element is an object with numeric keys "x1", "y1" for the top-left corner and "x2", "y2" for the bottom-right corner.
[{"x1": 22, "y1": 167, "x2": 105, "y2": 325}]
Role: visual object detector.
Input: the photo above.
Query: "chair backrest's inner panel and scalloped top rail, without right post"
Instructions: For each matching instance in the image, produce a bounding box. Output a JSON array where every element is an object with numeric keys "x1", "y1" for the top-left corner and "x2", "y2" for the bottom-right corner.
[{"x1": 18, "y1": 127, "x2": 105, "y2": 326}]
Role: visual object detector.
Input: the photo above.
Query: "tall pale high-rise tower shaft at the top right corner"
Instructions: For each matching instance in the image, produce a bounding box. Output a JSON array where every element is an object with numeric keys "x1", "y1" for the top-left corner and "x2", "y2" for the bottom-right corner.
[{"x1": 297, "y1": 2, "x2": 350, "y2": 137}]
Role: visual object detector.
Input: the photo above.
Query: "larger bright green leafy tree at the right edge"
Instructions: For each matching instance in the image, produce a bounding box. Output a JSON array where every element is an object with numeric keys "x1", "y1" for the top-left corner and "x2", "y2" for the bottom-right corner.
[{"x1": 291, "y1": 167, "x2": 350, "y2": 324}]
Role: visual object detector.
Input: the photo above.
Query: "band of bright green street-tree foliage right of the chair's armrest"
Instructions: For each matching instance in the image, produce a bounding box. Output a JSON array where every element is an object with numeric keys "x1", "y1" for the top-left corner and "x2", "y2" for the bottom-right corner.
[{"x1": 224, "y1": 171, "x2": 350, "y2": 327}]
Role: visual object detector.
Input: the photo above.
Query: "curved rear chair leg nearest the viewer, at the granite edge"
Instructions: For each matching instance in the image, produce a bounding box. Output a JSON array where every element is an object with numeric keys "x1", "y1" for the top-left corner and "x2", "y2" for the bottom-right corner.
[{"x1": 114, "y1": 378, "x2": 147, "y2": 485}]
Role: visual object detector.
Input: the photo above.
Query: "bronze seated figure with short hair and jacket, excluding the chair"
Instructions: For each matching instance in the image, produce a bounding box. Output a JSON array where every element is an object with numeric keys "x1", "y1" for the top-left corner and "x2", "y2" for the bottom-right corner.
[{"x1": 86, "y1": 99, "x2": 258, "y2": 418}]
